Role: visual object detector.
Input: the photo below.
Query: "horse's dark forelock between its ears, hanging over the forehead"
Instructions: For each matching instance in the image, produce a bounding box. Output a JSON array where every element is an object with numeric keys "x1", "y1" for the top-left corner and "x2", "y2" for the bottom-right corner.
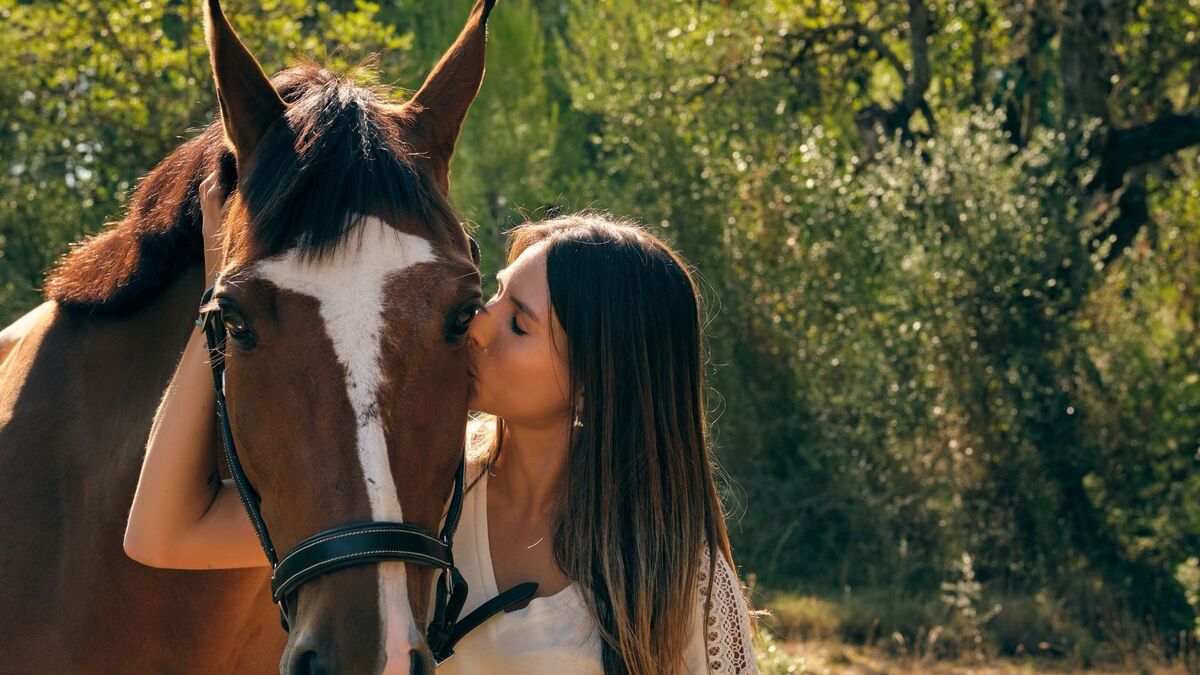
[{"x1": 241, "y1": 64, "x2": 457, "y2": 258}]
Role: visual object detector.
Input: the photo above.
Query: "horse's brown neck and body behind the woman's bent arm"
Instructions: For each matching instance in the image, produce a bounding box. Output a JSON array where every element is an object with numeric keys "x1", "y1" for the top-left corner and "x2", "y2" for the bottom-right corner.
[{"x1": 0, "y1": 260, "x2": 286, "y2": 673}]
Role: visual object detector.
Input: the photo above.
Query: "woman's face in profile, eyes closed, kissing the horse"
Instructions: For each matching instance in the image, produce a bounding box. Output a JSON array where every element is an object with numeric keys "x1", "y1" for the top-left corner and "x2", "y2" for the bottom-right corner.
[{"x1": 467, "y1": 239, "x2": 571, "y2": 428}]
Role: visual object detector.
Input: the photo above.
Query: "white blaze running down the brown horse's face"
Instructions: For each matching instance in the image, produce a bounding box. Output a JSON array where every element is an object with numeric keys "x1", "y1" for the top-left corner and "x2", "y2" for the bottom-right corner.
[{"x1": 257, "y1": 216, "x2": 437, "y2": 668}]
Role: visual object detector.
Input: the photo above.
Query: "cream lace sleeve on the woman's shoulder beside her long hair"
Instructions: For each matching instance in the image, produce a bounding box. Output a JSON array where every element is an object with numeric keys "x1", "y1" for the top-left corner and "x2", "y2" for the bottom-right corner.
[{"x1": 686, "y1": 549, "x2": 758, "y2": 675}]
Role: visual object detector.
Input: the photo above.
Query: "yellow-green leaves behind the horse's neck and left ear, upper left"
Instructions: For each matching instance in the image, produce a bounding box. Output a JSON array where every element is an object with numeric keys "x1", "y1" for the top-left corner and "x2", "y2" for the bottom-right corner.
[{"x1": 0, "y1": 0, "x2": 412, "y2": 321}]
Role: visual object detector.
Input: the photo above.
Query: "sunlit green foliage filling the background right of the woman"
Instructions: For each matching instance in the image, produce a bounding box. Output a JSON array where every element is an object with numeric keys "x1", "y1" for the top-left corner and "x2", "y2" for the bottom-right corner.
[{"x1": 554, "y1": 0, "x2": 1200, "y2": 653}]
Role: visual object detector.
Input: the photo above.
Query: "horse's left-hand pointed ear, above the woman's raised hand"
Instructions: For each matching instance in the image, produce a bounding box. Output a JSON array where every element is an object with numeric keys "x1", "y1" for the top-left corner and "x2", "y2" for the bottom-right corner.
[{"x1": 204, "y1": 0, "x2": 287, "y2": 162}]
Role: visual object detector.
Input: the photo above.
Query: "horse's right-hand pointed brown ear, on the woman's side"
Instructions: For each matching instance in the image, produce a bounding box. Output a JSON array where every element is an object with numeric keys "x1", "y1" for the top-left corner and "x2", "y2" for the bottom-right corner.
[{"x1": 398, "y1": 0, "x2": 496, "y2": 192}]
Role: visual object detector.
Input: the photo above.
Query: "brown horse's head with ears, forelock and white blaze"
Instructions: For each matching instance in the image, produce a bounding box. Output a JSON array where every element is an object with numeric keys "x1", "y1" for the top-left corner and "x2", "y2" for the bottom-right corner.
[{"x1": 206, "y1": 0, "x2": 493, "y2": 673}]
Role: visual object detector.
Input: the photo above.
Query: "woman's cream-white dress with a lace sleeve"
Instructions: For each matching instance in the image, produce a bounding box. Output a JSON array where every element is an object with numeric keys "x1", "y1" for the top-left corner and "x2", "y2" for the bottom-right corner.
[{"x1": 438, "y1": 461, "x2": 758, "y2": 675}]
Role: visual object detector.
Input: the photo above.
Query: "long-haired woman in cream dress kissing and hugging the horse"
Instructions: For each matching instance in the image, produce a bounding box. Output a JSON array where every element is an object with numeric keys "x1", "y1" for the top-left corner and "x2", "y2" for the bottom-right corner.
[{"x1": 126, "y1": 177, "x2": 757, "y2": 674}]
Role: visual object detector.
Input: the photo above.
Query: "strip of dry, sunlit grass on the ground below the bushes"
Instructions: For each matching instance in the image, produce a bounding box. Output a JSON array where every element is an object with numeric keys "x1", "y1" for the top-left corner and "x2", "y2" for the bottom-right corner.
[{"x1": 755, "y1": 592, "x2": 1200, "y2": 675}]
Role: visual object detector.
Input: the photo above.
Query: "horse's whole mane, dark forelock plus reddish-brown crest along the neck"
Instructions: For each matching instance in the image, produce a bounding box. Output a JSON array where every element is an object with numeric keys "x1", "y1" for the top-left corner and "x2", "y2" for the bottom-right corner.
[{"x1": 44, "y1": 62, "x2": 456, "y2": 316}]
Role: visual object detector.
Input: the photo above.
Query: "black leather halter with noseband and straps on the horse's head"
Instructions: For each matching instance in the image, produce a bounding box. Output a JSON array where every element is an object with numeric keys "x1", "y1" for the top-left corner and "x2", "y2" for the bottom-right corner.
[{"x1": 197, "y1": 275, "x2": 538, "y2": 664}]
